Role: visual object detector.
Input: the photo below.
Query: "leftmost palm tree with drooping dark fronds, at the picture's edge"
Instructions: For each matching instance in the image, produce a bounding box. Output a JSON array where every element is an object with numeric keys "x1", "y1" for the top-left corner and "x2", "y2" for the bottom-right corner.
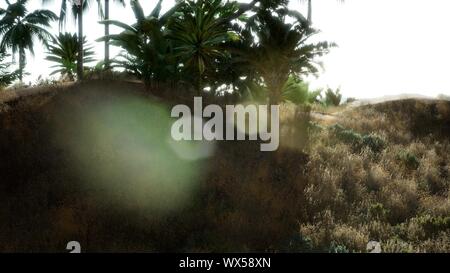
[{"x1": 0, "y1": 0, "x2": 58, "y2": 81}]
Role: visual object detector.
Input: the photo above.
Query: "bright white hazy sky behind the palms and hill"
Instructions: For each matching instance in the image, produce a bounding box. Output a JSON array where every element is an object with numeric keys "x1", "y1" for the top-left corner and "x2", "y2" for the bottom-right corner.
[{"x1": 2, "y1": 0, "x2": 450, "y2": 98}]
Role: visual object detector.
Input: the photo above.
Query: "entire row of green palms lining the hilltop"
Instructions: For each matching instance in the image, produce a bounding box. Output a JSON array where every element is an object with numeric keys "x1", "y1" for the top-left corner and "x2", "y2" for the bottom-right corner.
[{"x1": 0, "y1": 0, "x2": 334, "y2": 104}]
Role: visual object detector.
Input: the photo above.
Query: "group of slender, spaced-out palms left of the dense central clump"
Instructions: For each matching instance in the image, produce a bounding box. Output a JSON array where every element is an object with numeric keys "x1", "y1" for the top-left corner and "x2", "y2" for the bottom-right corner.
[{"x1": 0, "y1": 0, "x2": 125, "y2": 81}]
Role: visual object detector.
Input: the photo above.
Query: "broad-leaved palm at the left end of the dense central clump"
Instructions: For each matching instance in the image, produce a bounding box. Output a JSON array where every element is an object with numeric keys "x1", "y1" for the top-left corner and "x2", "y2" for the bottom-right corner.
[{"x1": 97, "y1": 0, "x2": 181, "y2": 86}]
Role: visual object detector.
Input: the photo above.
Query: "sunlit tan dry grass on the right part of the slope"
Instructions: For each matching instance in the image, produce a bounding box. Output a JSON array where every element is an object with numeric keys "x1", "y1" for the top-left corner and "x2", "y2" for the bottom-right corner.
[{"x1": 300, "y1": 100, "x2": 450, "y2": 252}]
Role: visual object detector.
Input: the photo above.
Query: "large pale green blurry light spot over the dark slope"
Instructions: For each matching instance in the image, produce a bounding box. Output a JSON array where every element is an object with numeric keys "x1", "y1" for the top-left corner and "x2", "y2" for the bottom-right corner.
[{"x1": 54, "y1": 92, "x2": 214, "y2": 214}]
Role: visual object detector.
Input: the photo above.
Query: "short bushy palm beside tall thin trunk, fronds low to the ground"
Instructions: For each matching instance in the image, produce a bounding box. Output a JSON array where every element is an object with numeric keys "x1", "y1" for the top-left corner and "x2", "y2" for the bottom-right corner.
[{"x1": 45, "y1": 32, "x2": 94, "y2": 81}]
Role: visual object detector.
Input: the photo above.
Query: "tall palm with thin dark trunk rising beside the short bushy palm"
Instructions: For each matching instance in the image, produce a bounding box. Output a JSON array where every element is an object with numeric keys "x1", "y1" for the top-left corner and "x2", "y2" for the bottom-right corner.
[{"x1": 42, "y1": 0, "x2": 103, "y2": 80}]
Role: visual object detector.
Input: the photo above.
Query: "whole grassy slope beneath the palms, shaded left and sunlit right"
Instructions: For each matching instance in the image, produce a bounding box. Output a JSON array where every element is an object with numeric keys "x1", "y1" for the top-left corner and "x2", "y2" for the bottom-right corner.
[{"x1": 0, "y1": 81, "x2": 450, "y2": 252}]
